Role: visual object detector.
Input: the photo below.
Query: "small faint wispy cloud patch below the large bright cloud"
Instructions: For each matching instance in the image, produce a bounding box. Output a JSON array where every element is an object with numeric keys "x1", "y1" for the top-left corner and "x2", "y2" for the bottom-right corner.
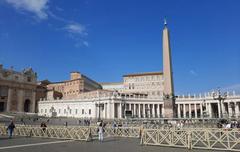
[{"x1": 64, "y1": 23, "x2": 88, "y2": 36}]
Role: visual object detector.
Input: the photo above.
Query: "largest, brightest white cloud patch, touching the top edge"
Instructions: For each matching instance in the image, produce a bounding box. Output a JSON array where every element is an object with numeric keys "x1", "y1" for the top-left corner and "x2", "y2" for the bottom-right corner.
[{"x1": 5, "y1": 0, "x2": 49, "y2": 19}]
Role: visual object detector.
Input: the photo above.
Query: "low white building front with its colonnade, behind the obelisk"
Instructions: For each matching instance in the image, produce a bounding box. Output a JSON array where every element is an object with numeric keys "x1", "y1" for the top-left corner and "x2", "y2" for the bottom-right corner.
[{"x1": 39, "y1": 90, "x2": 240, "y2": 119}]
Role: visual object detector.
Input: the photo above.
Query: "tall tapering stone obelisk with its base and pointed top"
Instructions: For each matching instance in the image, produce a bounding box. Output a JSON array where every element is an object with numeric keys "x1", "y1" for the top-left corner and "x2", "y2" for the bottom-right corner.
[{"x1": 163, "y1": 20, "x2": 176, "y2": 118}]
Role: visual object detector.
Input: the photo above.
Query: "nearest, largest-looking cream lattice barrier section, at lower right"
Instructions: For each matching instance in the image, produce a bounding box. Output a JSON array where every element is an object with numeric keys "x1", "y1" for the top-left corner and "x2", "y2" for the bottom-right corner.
[{"x1": 141, "y1": 128, "x2": 240, "y2": 151}]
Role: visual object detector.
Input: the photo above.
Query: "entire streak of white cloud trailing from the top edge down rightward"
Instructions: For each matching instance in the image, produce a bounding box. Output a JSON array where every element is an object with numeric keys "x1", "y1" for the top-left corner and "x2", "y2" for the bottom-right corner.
[{"x1": 3, "y1": 0, "x2": 89, "y2": 47}]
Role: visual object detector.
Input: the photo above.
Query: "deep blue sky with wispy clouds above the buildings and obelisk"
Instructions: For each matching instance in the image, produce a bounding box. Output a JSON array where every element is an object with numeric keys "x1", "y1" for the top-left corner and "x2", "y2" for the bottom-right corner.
[{"x1": 0, "y1": 0, "x2": 240, "y2": 94}]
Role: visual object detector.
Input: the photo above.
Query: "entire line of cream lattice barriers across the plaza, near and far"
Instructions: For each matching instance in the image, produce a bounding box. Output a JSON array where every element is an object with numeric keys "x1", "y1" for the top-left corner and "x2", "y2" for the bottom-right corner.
[{"x1": 0, "y1": 125, "x2": 240, "y2": 151}]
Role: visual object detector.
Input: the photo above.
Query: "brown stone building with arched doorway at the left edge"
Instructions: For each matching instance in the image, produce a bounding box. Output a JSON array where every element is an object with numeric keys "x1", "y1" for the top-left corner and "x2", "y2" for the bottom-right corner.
[{"x1": 0, "y1": 65, "x2": 37, "y2": 112}]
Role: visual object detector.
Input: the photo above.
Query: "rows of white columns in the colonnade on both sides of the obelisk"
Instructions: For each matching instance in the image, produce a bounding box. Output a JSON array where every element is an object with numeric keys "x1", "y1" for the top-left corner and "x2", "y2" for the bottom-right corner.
[{"x1": 114, "y1": 101, "x2": 240, "y2": 118}]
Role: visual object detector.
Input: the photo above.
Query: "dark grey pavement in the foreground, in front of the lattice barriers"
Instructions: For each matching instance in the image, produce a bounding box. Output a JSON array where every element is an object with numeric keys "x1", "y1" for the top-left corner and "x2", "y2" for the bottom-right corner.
[{"x1": 0, "y1": 137, "x2": 224, "y2": 152}]
